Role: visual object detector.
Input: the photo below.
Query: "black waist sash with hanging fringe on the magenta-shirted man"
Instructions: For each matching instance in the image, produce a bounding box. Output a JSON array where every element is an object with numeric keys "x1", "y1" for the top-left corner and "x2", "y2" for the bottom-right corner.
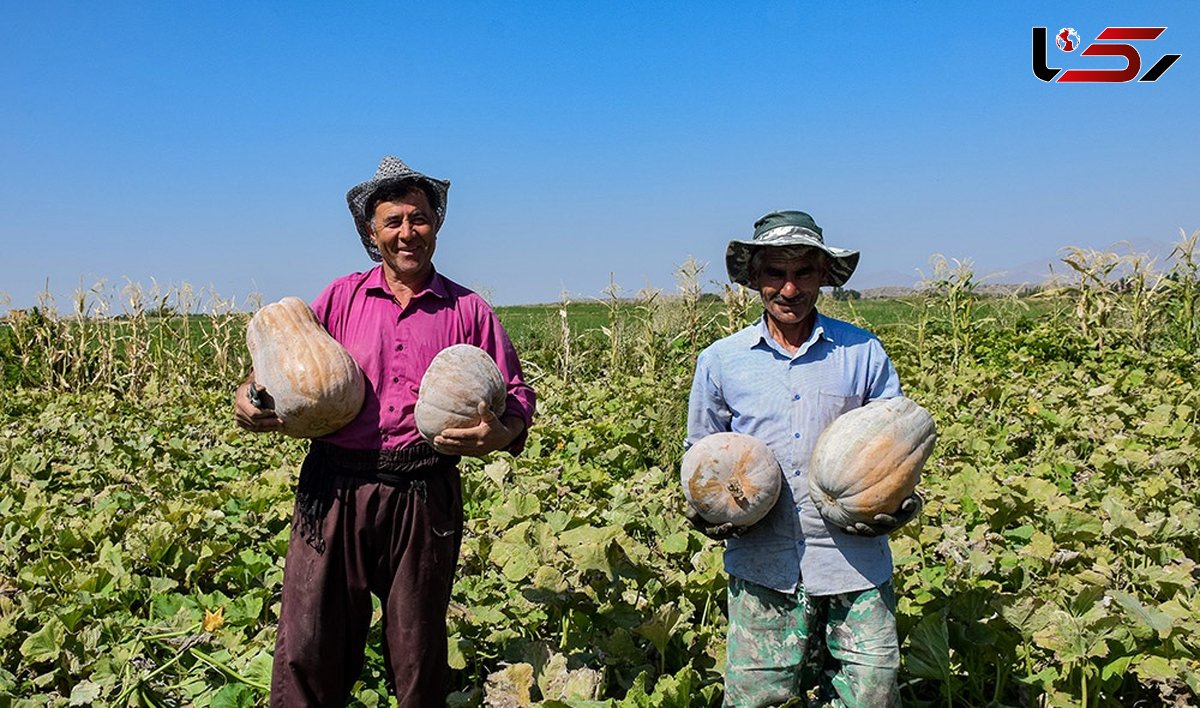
[{"x1": 296, "y1": 440, "x2": 462, "y2": 553}]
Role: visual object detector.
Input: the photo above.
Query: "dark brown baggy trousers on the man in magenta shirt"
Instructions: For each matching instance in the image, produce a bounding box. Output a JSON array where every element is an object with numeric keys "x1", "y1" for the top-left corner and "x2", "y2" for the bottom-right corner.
[{"x1": 271, "y1": 467, "x2": 463, "y2": 708}]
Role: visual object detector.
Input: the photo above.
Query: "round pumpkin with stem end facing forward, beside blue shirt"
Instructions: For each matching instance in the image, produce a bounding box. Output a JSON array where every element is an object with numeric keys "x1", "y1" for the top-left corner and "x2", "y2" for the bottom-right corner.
[{"x1": 679, "y1": 433, "x2": 782, "y2": 527}]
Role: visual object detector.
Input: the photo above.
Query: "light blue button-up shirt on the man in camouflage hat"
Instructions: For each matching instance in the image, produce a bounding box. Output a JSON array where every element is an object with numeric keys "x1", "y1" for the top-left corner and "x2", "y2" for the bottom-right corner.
[{"x1": 686, "y1": 313, "x2": 901, "y2": 595}]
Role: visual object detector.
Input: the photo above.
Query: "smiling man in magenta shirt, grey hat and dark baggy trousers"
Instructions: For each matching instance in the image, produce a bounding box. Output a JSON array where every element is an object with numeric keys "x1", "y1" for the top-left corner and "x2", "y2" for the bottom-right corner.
[{"x1": 235, "y1": 156, "x2": 535, "y2": 708}]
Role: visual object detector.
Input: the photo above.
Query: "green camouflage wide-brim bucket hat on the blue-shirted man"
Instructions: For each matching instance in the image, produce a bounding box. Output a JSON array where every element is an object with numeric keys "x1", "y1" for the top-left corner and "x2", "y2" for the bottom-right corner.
[{"x1": 725, "y1": 211, "x2": 858, "y2": 289}]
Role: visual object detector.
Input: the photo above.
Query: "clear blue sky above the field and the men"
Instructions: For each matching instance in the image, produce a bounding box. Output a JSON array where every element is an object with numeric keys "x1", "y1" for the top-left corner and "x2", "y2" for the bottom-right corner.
[{"x1": 0, "y1": 0, "x2": 1200, "y2": 307}]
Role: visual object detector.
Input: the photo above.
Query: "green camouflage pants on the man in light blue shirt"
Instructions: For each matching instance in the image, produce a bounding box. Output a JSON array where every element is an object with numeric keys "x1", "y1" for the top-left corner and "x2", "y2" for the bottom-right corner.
[{"x1": 725, "y1": 577, "x2": 900, "y2": 708}]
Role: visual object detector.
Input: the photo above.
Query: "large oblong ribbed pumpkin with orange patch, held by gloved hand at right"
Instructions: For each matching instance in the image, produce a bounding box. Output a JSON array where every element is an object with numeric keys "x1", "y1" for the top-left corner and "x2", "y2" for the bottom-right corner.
[{"x1": 809, "y1": 397, "x2": 937, "y2": 528}]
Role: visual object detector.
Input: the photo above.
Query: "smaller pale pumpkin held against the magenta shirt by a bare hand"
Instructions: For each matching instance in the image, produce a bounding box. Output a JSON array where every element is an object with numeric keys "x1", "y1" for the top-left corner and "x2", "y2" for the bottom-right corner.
[{"x1": 415, "y1": 344, "x2": 508, "y2": 456}]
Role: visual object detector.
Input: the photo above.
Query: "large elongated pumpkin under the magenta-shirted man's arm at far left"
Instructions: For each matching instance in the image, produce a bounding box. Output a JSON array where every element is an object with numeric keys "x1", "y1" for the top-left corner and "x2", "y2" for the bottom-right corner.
[{"x1": 246, "y1": 298, "x2": 366, "y2": 438}]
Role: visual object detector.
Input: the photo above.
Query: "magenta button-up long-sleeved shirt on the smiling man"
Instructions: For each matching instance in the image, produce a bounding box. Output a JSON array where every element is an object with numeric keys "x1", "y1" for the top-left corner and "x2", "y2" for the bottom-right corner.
[{"x1": 312, "y1": 265, "x2": 535, "y2": 452}]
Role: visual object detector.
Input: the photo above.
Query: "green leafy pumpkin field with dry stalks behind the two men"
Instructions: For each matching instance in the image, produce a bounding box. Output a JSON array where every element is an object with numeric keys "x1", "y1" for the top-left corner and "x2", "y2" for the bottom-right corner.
[{"x1": 0, "y1": 241, "x2": 1200, "y2": 707}]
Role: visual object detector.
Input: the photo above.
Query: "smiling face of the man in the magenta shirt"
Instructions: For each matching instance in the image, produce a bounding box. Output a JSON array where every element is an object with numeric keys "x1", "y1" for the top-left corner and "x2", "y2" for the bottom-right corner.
[{"x1": 372, "y1": 190, "x2": 439, "y2": 283}]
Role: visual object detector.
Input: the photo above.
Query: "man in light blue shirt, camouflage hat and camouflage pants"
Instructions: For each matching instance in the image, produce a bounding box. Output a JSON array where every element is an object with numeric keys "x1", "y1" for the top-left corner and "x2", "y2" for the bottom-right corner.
[{"x1": 688, "y1": 211, "x2": 920, "y2": 707}]
